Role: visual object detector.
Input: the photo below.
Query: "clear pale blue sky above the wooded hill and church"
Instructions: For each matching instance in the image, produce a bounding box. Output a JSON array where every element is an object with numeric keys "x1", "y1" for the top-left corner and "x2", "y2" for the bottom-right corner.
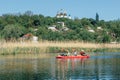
[{"x1": 0, "y1": 0, "x2": 120, "y2": 21}]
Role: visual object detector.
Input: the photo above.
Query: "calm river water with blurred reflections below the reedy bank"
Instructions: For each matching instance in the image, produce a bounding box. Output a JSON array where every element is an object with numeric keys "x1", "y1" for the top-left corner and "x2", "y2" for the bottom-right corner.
[{"x1": 0, "y1": 53, "x2": 120, "y2": 80}]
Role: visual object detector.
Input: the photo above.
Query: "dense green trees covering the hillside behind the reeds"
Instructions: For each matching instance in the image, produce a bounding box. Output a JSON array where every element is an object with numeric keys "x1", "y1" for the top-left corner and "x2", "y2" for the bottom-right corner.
[{"x1": 0, "y1": 11, "x2": 120, "y2": 43}]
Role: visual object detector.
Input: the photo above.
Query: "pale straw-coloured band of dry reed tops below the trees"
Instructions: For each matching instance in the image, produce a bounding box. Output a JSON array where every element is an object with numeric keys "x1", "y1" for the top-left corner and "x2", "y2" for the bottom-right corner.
[{"x1": 0, "y1": 41, "x2": 120, "y2": 48}]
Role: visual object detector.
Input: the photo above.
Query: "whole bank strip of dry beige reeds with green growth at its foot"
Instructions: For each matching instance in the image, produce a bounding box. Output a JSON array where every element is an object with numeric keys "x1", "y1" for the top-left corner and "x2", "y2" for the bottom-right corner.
[{"x1": 0, "y1": 41, "x2": 120, "y2": 55}]
